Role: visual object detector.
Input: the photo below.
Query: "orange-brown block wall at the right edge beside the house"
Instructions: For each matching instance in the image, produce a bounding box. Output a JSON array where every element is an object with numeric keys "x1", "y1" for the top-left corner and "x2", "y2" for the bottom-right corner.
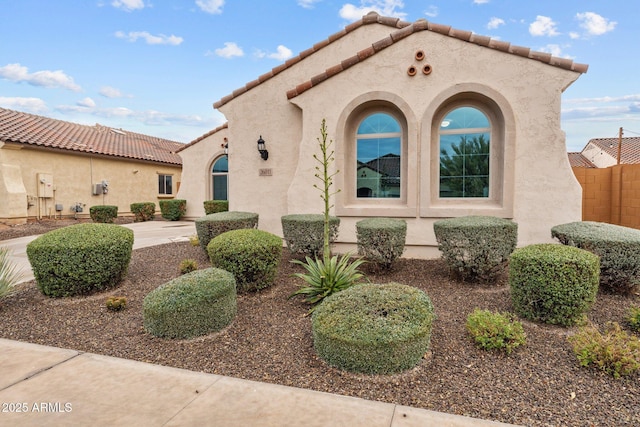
[{"x1": 573, "y1": 164, "x2": 640, "y2": 229}]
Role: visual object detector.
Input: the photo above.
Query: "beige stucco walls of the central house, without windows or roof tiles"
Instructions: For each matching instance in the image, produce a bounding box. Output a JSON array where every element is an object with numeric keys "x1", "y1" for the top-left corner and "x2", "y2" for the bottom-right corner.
[{"x1": 178, "y1": 15, "x2": 581, "y2": 257}]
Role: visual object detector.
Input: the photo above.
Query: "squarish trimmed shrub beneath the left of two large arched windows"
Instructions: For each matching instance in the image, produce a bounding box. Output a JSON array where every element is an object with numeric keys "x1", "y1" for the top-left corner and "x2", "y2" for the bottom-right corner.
[{"x1": 356, "y1": 218, "x2": 407, "y2": 270}]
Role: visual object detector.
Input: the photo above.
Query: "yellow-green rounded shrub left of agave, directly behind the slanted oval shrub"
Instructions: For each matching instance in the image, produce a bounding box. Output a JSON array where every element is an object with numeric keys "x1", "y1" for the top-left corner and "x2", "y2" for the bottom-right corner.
[{"x1": 207, "y1": 229, "x2": 282, "y2": 292}]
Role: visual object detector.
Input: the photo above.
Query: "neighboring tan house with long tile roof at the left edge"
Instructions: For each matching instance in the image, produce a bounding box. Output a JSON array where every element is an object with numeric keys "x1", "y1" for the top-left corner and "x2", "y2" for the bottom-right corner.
[{"x1": 0, "y1": 108, "x2": 184, "y2": 224}]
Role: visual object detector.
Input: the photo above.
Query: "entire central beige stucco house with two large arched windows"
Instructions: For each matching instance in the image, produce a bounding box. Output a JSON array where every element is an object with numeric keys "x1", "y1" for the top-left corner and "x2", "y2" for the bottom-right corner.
[{"x1": 178, "y1": 13, "x2": 587, "y2": 257}]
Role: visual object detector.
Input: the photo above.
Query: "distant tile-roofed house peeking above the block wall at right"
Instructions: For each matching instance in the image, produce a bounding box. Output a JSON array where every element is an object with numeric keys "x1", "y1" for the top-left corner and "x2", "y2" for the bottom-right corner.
[{"x1": 576, "y1": 137, "x2": 640, "y2": 168}]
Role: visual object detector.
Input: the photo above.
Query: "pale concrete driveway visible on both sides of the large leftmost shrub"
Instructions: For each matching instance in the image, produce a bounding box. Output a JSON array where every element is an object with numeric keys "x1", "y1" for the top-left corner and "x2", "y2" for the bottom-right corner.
[{"x1": 0, "y1": 220, "x2": 196, "y2": 283}]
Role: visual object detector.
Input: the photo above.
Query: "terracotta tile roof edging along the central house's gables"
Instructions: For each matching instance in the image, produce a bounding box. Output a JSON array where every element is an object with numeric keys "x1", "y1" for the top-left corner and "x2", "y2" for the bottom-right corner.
[{"x1": 213, "y1": 12, "x2": 589, "y2": 109}]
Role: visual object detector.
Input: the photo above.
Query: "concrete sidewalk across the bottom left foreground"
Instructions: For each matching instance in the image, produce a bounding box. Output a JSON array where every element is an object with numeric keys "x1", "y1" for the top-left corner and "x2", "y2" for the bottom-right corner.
[{"x1": 0, "y1": 339, "x2": 507, "y2": 427}]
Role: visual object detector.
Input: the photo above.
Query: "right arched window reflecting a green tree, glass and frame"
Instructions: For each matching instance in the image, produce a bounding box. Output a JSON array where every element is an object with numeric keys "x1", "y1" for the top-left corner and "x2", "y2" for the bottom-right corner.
[{"x1": 438, "y1": 107, "x2": 491, "y2": 198}]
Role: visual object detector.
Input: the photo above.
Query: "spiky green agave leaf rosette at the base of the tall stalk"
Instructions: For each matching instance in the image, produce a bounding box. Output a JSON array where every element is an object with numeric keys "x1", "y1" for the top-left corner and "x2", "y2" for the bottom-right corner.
[{"x1": 289, "y1": 254, "x2": 365, "y2": 313}]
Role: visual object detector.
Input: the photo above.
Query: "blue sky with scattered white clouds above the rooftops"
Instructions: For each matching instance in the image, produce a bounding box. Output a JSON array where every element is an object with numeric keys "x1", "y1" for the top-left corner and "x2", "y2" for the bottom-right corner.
[{"x1": 0, "y1": 0, "x2": 640, "y2": 151}]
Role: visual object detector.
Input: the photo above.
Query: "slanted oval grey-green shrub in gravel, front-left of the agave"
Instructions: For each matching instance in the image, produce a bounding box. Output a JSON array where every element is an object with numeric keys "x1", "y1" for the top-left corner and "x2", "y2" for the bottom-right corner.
[{"x1": 142, "y1": 268, "x2": 238, "y2": 338}]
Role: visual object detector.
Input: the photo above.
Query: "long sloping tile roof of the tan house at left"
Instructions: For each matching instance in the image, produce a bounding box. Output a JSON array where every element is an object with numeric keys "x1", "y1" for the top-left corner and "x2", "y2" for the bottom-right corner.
[{"x1": 0, "y1": 108, "x2": 184, "y2": 165}]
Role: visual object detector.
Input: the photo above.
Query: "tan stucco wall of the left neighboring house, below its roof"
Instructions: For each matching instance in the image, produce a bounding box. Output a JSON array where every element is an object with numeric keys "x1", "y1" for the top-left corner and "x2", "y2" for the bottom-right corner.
[{"x1": 0, "y1": 141, "x2": 181, "y2": 224}]
